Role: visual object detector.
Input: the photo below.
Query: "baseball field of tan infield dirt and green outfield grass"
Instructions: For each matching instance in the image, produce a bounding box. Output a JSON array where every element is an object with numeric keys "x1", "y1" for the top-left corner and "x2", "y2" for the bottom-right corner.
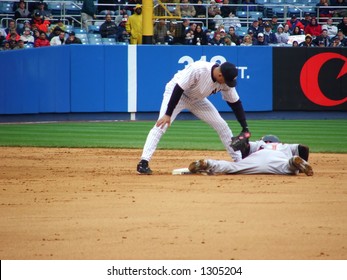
[{"x1": 0, "y1": 120, "x2": 347, "y2": 260}]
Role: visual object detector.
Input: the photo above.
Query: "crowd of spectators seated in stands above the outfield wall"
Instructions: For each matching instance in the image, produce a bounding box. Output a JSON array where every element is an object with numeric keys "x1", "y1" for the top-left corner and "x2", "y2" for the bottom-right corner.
[{"x1": 0, "y1": 0, "x2": 347, "y2": 50}]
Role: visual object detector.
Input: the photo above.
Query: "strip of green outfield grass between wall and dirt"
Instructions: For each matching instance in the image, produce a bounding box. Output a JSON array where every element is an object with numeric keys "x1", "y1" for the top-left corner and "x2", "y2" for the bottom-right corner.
[{"x1": 0, "y1": 120, "x2": 347, "y2": 153}]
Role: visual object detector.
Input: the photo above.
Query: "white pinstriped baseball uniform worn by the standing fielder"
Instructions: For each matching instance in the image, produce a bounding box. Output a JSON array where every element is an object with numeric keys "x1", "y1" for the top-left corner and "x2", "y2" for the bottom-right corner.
[{"x1": 141, "y1": 61, "x2": 247, "y2": 164}]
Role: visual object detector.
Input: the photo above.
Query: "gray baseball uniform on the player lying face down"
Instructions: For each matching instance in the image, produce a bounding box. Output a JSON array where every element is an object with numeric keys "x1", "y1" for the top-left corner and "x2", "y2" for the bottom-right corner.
[{"x1": 207, "y1": 140, "x2": 299, "y2": 175}]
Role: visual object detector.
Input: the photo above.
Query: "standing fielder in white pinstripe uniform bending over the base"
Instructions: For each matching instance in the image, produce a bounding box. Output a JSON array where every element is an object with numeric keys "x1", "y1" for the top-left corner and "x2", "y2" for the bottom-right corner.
[{"x1": 137, "y1": 61, "x2": 249, "y2": 175}]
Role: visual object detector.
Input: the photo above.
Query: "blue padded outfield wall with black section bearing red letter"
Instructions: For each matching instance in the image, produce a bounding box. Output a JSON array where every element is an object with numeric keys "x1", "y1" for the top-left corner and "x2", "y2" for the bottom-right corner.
[{"x1": 0, "y1": 45, "x2": 347, "y2": 114}]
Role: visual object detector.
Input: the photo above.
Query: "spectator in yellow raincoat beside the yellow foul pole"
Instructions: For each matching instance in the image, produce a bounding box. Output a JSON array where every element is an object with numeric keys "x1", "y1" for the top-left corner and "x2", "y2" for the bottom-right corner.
[{"x1": 125, "y1": 4, "x2": 142, "y2": 45}]
